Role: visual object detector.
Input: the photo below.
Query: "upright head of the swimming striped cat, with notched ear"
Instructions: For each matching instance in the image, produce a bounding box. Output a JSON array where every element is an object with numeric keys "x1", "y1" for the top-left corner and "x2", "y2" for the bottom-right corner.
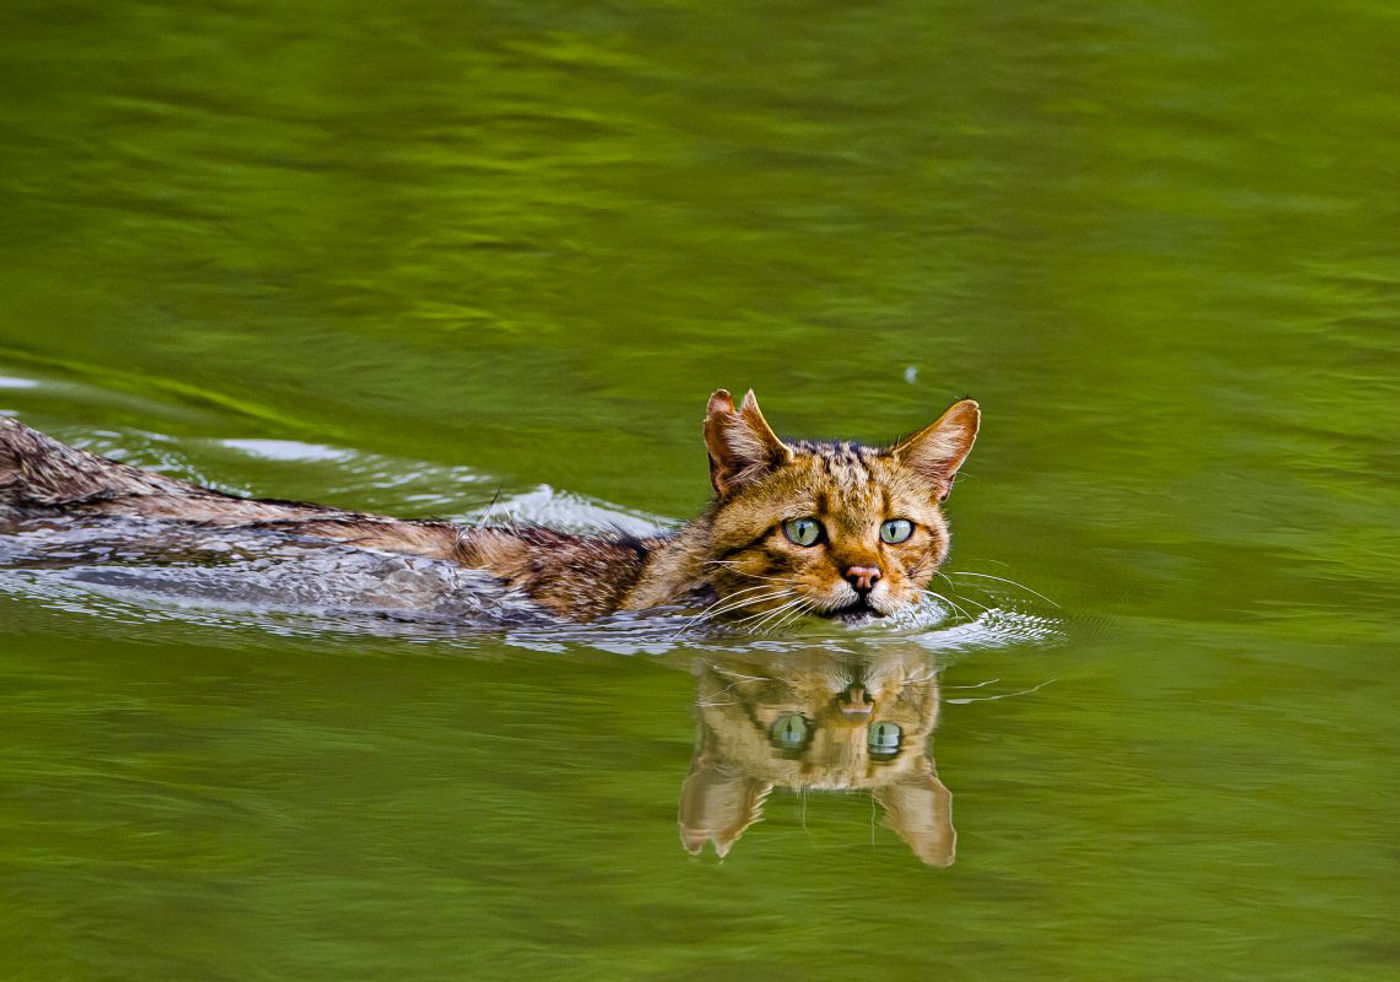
[{"x1": 706, "y1": 389, "x2": 980, "y2": 626}]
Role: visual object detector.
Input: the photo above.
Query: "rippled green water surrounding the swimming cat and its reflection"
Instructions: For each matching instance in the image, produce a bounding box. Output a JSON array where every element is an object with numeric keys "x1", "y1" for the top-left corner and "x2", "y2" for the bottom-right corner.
[{"x1": 0, "y1": 0, "x2": 1400, "y2": 982}]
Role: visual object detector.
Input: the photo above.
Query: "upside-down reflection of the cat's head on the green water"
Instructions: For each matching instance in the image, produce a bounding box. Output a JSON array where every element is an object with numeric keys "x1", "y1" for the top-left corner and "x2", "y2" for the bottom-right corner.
[{"x1": 680, "y1": 653, "x2": 958, "y2": 866}]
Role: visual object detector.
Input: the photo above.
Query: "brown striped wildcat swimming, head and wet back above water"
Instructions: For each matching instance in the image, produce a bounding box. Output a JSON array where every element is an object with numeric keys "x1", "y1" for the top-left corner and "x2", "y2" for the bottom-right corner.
[{"x1": 0, "y1": 389, "x2": 980, "y2": 626}]
